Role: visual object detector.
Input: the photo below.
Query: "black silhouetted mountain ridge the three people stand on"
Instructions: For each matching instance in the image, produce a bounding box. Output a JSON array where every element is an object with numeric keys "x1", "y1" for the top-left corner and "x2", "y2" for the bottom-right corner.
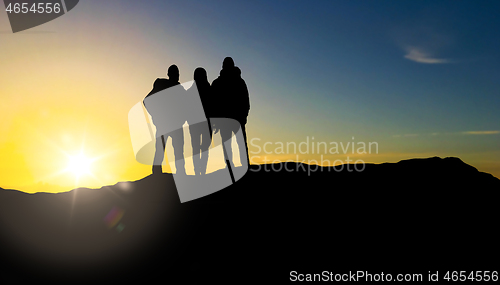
[{"x1": 0, "y1": 157, "x2": 500, "y2": 284}]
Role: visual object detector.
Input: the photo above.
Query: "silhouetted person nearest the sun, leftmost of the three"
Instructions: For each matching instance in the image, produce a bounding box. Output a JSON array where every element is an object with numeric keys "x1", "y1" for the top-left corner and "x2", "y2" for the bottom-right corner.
[{"x1": 144, "y1": 64, "x2": 186, "y2": 174}]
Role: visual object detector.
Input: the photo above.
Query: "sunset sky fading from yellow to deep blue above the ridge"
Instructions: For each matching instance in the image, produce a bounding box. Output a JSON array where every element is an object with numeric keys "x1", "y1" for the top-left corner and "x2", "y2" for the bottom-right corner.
[{"x1": 0, "y1": 0, "x2": 500, "y2": 192}]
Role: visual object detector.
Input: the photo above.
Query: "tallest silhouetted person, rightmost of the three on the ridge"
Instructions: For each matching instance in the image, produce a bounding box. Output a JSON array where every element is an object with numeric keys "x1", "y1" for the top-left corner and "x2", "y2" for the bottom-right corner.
[{"x1": 212, "y1": 57, "x2": 250, "y2": 164}]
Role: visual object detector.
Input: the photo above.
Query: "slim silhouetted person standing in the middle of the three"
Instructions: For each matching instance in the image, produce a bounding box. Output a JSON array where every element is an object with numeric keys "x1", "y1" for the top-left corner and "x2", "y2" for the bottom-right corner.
[{"x1": 187, "y1": 67, "x2": 213, "y2": 175}]
